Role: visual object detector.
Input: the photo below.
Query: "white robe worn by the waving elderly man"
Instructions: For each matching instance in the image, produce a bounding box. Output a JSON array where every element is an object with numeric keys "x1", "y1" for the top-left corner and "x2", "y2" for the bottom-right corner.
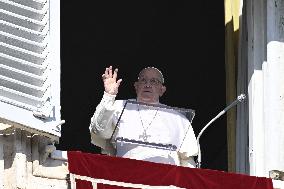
[{"x1": 89, "y1": 93, "x2": 198, "y2": 167}]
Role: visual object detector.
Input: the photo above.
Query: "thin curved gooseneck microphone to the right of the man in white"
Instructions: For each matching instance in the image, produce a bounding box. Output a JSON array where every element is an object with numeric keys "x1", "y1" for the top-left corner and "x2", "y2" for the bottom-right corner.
[{"x1": 196, "y1": 94, "x2": 246, "y2": 168}]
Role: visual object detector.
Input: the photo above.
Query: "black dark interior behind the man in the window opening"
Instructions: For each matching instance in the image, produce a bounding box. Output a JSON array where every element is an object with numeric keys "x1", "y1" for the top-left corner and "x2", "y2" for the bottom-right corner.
[{"x1": 57, "y1": 0, "x2": 227, "y2": 171}]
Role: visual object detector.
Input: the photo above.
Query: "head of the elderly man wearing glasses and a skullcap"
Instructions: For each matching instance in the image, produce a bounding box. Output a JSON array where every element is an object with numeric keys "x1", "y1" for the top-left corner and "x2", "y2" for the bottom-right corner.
[{"x1": 134, "y1": 68, "x2": 166, "y2": 104}]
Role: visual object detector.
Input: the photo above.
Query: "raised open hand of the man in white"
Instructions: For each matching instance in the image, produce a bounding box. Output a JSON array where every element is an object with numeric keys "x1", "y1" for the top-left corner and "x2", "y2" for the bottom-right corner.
[{"x1": 102, "y1": 66, "x2": 122, "y2": 95}]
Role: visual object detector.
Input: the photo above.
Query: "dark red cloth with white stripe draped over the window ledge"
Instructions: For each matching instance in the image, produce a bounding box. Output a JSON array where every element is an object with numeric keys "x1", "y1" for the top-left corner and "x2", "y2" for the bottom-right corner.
[{"x1": 67, "y1": 151, "x2": 273, "y2": 189}]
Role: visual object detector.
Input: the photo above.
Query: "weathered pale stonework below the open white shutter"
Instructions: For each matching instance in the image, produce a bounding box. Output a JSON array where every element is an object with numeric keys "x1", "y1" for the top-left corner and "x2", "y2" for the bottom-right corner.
[{"x1": 0, "y1": 124, "x2": 70, "y2": 189}]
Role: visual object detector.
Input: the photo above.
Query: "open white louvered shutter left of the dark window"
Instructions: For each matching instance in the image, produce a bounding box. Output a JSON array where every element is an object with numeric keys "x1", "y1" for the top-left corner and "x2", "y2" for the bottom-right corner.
[{"x1": 0, "y1": 0, "x2": 62, "y2": 140}]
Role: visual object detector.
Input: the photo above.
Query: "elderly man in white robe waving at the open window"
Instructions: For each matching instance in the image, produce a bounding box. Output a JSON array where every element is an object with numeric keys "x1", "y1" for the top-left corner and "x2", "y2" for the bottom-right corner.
[{"x1": 89, "y1": 66, "x2": 198, "y2": 167}]
